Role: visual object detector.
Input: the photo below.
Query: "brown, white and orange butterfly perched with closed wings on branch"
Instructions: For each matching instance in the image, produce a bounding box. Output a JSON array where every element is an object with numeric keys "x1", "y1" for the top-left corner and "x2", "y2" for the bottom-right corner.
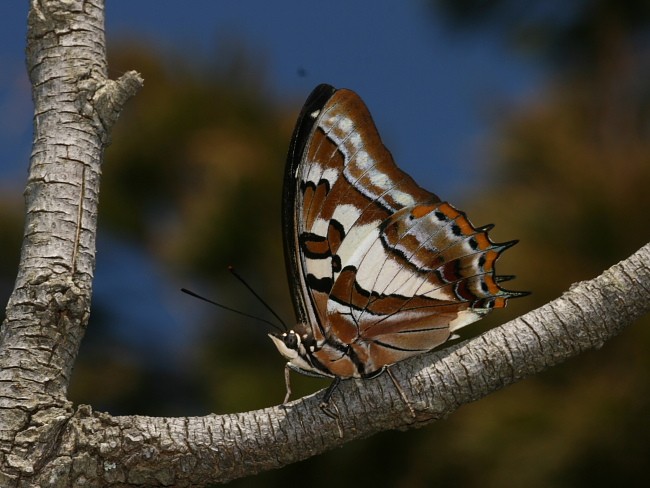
[{"x1": 269, "y1": 84, "x2": 527, "y2": 406}]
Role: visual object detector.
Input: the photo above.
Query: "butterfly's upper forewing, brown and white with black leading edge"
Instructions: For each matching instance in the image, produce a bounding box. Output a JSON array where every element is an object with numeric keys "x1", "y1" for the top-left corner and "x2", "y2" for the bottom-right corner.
[{"x1": 282, "y1": 85, "x2": 438, "y2": 336}]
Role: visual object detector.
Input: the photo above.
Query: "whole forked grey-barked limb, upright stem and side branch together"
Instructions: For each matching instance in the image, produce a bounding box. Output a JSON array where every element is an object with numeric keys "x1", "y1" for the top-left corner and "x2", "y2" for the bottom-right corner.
[{"x1": 0, "y1": 0, "x2": 650, "y2": 487}]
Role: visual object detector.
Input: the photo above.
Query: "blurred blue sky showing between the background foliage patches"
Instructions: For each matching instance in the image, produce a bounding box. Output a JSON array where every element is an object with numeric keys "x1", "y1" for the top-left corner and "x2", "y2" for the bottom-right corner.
[{"x1": 0, "y1": 0, "x2": 540, "y2": 366}]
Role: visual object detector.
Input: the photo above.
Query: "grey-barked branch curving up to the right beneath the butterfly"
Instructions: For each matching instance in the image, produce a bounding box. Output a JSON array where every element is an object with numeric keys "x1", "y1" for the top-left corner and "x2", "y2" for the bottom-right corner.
[{"x1": 38, "y1": 244, "x2": 650, "y2": 486}]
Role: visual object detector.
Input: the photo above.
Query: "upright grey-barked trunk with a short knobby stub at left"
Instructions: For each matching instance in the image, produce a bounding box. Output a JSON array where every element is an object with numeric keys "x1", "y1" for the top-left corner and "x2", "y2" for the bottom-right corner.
[{"x1": 0, "y1": 0, "x2": 142, "y2": 486}]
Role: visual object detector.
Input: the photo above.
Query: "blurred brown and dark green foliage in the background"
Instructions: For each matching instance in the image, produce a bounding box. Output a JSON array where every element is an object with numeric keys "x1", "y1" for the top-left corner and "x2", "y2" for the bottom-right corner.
[{"x1": 0, "y1": 0, "x2": 650, "y2": 488}]
